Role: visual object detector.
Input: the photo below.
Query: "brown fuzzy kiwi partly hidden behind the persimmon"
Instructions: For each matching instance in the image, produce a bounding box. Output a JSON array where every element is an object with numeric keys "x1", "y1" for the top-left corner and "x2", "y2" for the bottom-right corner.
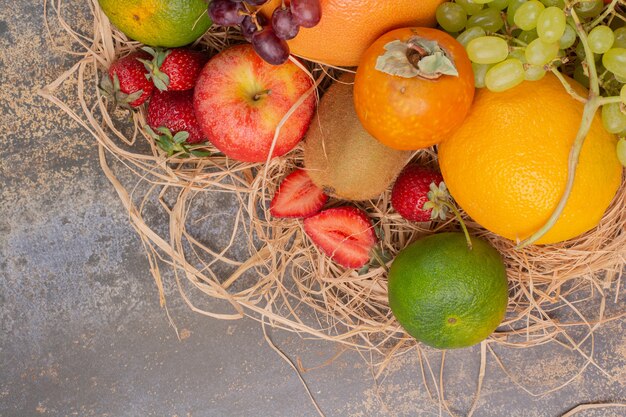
[{"x1": 304, "y1": 74, "x2": 412, "y2": 201}]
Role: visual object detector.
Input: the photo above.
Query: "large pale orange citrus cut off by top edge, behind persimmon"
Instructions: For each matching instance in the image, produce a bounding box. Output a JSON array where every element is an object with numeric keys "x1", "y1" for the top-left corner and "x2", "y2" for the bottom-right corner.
[{"x1": 261, "y1": 0, "x2": 445, "y2": 66}]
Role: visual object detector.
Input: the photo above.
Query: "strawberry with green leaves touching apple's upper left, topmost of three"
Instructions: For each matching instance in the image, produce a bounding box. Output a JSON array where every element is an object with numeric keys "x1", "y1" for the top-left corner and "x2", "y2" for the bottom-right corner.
[{"x1": 142, "y1": 47, "x2": 209, "y2": 91}]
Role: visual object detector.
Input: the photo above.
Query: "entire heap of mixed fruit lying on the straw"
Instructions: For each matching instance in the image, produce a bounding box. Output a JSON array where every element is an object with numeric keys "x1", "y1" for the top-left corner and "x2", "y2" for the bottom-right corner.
[{"x1": 85, "y1": 0, "x2": 626, "y2": 349}]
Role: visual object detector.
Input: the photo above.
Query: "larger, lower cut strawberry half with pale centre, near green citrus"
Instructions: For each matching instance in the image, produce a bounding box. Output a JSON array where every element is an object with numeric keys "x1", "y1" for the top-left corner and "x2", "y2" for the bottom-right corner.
[{"x1": 304, "y1": 206, "x2": 378, "y2": 268}]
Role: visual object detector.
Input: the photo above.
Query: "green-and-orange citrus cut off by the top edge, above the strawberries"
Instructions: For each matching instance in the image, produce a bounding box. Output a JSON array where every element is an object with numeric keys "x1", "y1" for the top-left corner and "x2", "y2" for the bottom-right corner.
[{"x1": 99, "y1": 0, "x2": 211, "y2": 48}]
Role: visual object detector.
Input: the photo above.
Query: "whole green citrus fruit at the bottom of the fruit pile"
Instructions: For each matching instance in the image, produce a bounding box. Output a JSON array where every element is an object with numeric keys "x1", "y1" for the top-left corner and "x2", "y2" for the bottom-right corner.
[{"x1": 389, "y1": 233, "x2": 508, "y2": 349}]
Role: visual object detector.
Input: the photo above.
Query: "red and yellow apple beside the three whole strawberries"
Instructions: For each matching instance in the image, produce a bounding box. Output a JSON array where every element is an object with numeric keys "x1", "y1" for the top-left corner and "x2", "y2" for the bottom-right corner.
[{"x1": 194, "y1": 45, "x2": 315, "y2": 162}]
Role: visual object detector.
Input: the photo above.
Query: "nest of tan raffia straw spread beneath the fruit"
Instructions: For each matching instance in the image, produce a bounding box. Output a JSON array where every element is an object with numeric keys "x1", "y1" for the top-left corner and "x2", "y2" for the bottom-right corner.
[{"x1": 40, "y1": 0, "x2": 626, "y2": 415}]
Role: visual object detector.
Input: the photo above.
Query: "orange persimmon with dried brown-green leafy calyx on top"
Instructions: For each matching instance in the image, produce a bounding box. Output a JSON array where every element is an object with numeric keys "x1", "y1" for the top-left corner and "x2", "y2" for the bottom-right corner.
[{"x1": 354, "y1": 28, "x2": 474, "y2": 150}]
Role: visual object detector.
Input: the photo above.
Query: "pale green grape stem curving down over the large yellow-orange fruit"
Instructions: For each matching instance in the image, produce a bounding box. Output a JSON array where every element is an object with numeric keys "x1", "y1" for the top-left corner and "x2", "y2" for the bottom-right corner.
[{"x1": 516, "y1": 4, "x2": 607, "y2": 249}]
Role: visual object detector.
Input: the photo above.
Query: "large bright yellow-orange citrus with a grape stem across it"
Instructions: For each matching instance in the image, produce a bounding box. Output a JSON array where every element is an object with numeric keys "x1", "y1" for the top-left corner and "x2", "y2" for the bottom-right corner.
[{"x1": 439, "y1": 74, "x2": 622, "y2": 244}]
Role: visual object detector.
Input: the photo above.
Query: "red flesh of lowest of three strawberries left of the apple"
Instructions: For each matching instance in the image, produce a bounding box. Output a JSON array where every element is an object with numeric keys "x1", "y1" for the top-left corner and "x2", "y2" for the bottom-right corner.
[{"x1": 146, "y1": 90, "x2": 206, "y2": 144}]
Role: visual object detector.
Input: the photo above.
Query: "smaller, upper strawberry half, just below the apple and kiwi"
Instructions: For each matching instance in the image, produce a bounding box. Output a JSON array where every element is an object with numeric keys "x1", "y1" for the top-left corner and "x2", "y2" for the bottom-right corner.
[{"x1": 270, "y1": 169, "x2": 328, "y2": 218}]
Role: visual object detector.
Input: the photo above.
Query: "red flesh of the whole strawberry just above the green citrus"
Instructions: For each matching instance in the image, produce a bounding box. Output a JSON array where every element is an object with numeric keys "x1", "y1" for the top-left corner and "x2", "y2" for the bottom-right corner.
[{"x1": 391, "y1": 165, "x2": 443, "y2": 222}]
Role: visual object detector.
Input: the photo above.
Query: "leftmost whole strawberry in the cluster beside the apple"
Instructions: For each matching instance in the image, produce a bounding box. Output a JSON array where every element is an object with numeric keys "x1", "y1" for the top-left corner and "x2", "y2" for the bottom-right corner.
[{"x1": 105, "y1": 51, "x2": 154, "y2": 107}]
